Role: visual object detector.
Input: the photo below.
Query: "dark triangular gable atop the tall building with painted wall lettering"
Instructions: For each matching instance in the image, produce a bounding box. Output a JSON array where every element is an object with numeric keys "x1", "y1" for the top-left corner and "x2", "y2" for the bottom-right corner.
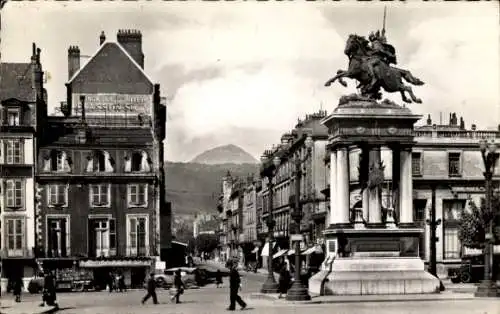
[{"x1": 68, "y1": 42, "x2": 154, "y2": 94}]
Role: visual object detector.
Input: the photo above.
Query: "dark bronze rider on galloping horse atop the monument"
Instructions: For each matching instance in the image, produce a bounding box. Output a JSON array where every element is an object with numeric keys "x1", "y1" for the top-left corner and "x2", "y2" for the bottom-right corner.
[{"x1": 325, "y1": 26, "x2": 424, "y2": 103}]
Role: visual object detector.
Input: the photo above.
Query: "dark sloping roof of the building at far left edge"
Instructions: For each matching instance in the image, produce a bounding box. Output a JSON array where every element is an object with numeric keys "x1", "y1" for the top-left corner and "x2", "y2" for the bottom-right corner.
[{"x1": 0, "y1": 63, "x2": 36, "y2": 102}]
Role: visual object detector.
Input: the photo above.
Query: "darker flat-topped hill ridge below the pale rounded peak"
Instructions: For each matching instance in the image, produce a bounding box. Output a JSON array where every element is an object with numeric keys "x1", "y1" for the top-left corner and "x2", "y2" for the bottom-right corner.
[{"x1": 165, "y1": 161, "x2": 259, "y2": 217}]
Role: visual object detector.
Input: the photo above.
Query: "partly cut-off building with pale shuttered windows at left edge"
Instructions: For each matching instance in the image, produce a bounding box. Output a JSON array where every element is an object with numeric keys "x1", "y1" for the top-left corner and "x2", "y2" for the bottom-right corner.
[{"x1": 0, "y1": 44, "x2": 47, "y2": 291}]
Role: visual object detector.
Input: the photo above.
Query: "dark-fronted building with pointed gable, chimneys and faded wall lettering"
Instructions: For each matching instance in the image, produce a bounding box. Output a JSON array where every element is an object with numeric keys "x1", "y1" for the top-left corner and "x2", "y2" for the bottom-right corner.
[{"x1": 36, "y1": 30, "x2": 168, "y2": 287}]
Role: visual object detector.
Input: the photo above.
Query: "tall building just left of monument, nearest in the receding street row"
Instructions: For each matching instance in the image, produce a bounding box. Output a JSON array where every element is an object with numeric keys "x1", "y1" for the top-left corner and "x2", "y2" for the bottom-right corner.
[{"x1": 260, "y1": 111, "x2": 328, "y2": 253}]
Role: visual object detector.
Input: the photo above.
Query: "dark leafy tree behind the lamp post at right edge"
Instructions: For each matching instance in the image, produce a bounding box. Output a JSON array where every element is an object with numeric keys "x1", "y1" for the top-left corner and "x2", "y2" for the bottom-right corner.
[{"x1": 458, "y1": 193, "x2": 500, "y2": 249}]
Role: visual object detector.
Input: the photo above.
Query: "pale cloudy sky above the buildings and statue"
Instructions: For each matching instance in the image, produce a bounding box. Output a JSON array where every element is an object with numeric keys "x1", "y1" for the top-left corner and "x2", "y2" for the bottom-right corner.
[{"x1": 0, "y1": 1, "x2": 500, "y2": 161}]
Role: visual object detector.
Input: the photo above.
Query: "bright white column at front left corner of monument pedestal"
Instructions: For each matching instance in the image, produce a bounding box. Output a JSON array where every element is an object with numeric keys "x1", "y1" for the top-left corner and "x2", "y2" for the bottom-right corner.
[{"x1": 335, "y1": 147, "x2": 350, "y2": 224}]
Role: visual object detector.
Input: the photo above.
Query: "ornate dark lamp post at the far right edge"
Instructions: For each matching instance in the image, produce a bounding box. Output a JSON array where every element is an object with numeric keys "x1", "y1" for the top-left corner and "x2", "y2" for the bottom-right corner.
[{"x1": 474, "y1": 140, "x2": 500, "y2": 297}]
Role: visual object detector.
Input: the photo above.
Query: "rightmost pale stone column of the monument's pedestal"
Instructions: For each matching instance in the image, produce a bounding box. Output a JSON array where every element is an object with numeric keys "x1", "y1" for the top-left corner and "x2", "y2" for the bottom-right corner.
[{"x1": 399, "y1": 148, "x2": 413, "y2": 225}]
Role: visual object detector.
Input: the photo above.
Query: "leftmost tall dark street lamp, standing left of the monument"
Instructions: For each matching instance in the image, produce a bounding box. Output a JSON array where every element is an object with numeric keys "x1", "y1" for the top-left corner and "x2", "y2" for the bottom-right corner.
[{"x1": 260, "y1": 156, "x2": 281, "y2": 293}]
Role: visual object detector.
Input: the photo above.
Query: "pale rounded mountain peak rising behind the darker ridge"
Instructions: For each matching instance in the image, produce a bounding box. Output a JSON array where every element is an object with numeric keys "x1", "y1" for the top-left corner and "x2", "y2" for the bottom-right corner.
[{"x1": 191, "y1": 144, "x2": 257, "y2": 165}]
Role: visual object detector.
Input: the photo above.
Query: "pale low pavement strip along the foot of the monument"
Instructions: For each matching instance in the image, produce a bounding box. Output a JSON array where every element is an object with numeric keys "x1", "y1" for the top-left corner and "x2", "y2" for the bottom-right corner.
[{"x1": 247, "y1": 292, "x2": 475, "y2": 304}]
